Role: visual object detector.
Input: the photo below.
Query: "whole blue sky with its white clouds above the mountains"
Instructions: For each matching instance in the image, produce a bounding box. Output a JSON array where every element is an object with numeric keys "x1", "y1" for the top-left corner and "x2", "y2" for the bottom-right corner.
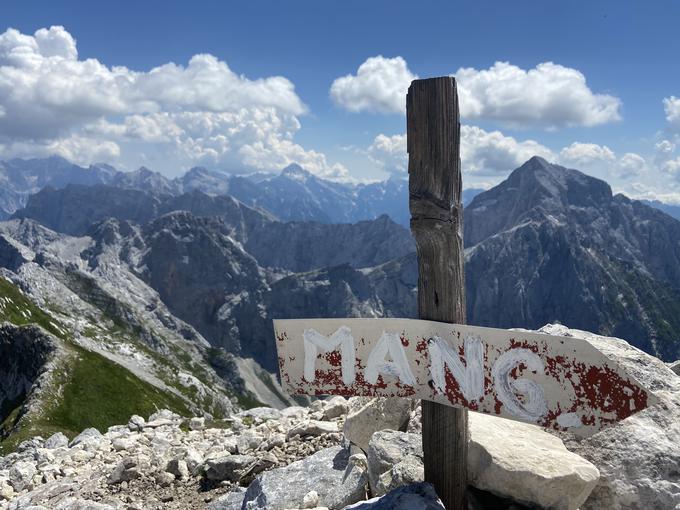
[{"x1": 0, "y1": 0, "x2": 680, "y2": 201}]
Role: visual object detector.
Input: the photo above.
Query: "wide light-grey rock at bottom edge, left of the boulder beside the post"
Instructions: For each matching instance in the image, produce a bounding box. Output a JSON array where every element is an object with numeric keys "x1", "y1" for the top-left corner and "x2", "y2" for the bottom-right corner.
[{"x1": 243, "y1": 447, "x2": 368, "y2": 510}]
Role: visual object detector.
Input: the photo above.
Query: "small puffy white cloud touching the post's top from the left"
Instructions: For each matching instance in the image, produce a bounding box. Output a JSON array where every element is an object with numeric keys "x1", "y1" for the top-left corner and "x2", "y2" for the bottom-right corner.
[{"x1": 330, "y1": 55, "x2": 418, "y2": 113}]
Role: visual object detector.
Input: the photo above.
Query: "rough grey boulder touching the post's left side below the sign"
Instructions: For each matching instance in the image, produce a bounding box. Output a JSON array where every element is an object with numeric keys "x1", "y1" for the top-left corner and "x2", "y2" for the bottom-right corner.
[{"x1": 367, "y1": 430, "x2": 424, "y2": 496}]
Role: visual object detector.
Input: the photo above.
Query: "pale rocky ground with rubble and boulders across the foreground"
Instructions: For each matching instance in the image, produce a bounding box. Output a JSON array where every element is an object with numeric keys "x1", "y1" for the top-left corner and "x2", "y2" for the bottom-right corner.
[{"x1": 0, "y1": 326, "x2": 680, "y2": 510}]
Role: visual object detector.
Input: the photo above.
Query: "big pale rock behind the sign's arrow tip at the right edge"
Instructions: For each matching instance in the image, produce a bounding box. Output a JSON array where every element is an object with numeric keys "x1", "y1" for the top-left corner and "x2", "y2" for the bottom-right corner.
[{"x1": 540, "y1": 325, "x2": 680, "y2": 510}]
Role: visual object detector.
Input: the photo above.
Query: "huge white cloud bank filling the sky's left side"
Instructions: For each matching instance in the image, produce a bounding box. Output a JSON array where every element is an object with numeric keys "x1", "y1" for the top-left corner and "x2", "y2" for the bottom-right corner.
[{"x1": 0, "y1": 26, "x2": 347, "y2": 177}]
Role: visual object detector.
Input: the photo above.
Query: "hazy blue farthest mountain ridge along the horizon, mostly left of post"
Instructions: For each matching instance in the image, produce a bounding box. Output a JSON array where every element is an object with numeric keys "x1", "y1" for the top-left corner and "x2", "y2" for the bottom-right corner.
[{"x1": 0, "y1": 157, "x2": 482, "y2": 226}]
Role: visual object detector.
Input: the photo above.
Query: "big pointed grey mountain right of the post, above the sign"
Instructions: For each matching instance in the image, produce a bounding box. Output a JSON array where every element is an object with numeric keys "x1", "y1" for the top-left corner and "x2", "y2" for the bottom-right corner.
[{"x1": 464, "y1": 158, "x2": 680, "y2": 361}]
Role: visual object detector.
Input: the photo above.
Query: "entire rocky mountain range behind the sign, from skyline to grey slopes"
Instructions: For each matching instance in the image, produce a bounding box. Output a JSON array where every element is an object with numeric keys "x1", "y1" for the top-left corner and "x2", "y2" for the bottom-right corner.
[{"x1": 0, "y1": 153, "x2": 680, "y2": 452}]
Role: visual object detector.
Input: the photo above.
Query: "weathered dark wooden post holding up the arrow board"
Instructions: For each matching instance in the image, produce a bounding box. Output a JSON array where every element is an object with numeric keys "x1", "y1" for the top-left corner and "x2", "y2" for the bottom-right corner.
[{"x1": 406, "y1": 77, "x2": 468, "y2": 510}]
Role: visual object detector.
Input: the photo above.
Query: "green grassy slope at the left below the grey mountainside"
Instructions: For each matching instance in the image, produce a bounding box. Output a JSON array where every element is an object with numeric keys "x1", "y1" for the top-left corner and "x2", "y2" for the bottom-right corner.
[{"x1": 0, "y1": 278, "x2": 190, "y2": 454}]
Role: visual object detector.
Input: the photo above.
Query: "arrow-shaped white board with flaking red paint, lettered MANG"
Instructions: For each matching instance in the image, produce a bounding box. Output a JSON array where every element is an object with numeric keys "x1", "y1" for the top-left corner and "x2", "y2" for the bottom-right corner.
[{"x1": 274, "y1": 319, "x2": 655, "y2": 435}]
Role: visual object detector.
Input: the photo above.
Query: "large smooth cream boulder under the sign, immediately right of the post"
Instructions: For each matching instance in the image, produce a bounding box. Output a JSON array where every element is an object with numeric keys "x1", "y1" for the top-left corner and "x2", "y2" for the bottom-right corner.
[{"x1": 468, "y1": 413, "x2": 599, "y2": 510}]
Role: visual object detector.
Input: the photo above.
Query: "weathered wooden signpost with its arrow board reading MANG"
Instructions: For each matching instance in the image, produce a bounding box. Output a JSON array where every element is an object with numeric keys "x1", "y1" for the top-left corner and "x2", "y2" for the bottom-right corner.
[{"x1": 274, "y1": 77, "x2": 654, "y2": 510}]
